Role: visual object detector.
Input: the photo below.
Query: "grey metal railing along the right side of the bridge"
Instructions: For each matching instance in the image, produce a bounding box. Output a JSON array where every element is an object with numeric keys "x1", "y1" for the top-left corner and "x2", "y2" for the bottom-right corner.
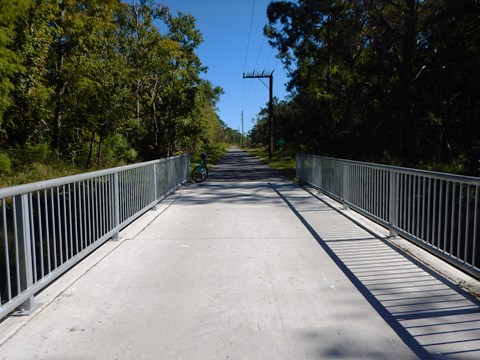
[{"x1": 297, "y1": 154, "x2": 480, "y2": 277}]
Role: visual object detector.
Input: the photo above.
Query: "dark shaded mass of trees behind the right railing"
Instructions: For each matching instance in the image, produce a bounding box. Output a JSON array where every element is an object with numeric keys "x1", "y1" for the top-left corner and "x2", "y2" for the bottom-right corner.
[{"x1": 251, "y1": 0, "x2": 480, "y2": 174}]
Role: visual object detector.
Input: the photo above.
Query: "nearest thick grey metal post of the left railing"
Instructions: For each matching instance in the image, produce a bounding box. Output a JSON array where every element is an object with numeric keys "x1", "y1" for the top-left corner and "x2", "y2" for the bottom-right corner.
[{"x1": 14, "y1": 194, "x2": 34, "y2": 315}]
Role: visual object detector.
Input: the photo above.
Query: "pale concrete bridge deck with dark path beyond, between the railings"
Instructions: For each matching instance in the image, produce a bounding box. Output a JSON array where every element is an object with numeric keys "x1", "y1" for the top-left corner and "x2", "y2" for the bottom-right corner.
[{"x1": 0, "y1": 150, "x2": 480, "y2": 360}]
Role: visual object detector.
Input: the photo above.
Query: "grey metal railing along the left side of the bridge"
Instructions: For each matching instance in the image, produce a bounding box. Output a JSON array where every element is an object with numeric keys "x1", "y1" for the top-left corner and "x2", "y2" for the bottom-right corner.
[{"x1": 0, "y1": 155, "x2": 190, "y2": 319}]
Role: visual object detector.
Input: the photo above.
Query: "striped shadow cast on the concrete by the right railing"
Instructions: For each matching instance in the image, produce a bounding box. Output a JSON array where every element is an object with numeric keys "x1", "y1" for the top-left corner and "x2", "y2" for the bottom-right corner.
[{"x1": 272, "y1": 185, "x2": 480, "y2": 359}]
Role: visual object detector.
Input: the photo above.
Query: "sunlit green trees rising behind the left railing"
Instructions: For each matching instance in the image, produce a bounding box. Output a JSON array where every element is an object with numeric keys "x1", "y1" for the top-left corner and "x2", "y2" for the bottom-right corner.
[{"x1": 0, "y1": 0, "x2": 231, "y2": 173}]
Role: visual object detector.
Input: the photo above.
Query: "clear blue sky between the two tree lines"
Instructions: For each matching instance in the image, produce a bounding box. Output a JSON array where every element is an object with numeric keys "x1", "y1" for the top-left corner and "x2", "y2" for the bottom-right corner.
[{"x1": 158, "y1": 0, "x2": 288, "y2": 133}]
